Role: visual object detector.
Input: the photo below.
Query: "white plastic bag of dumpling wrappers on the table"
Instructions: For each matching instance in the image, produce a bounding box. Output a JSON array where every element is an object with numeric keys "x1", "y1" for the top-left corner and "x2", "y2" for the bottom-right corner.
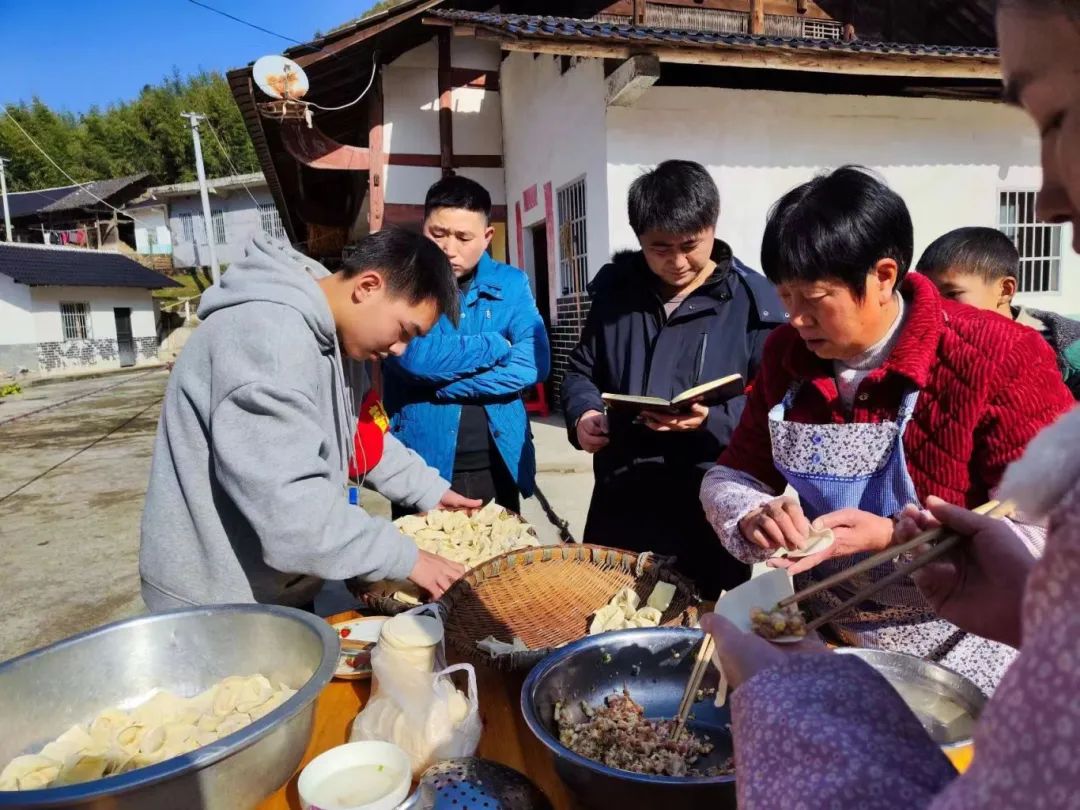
[{"x1": 349, "y1": 606, "x2": 482, "y2": 777}]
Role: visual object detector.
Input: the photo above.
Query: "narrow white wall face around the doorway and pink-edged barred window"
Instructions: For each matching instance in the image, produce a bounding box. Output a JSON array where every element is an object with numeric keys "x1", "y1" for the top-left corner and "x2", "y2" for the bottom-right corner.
[{"x1": 502, "y1": 53, "x2": 618, "y2": 320}]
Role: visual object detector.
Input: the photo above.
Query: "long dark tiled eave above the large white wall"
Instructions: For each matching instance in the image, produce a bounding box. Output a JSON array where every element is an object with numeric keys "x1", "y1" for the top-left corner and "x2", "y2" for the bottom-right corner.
[{"x1": 431, "y1": 10, "x2": 998, "y2": 59}]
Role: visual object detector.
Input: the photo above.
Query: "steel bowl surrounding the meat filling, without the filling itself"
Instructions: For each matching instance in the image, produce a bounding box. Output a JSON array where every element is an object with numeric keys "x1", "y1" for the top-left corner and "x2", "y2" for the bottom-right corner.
[{"x1": 522, "y1": 627, "x2": 735, "y2": 810}]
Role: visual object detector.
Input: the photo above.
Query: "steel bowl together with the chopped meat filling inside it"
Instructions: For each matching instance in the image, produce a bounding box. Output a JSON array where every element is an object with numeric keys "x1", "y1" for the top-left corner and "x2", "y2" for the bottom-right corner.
[{"x1": 522, "y1": 627, "x2": 735, "y2": 810}]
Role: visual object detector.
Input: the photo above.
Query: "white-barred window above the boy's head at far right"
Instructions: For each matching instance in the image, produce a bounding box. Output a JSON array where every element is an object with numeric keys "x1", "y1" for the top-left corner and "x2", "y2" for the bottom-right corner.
[{"x1": 998, "y1": 191, "x2": 1062, "y2": 293}]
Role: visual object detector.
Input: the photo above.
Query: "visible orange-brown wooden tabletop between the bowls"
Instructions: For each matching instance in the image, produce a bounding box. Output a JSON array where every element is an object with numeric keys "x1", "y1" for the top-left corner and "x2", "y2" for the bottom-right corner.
[{"x1": 258, "y1": 612, "x2": 578, "y2": 810}]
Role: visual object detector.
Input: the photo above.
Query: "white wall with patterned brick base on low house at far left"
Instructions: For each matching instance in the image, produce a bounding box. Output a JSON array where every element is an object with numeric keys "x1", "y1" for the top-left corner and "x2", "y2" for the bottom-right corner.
[{"x1": 30, "y1": 287, "x2": 158, "y2": 374}]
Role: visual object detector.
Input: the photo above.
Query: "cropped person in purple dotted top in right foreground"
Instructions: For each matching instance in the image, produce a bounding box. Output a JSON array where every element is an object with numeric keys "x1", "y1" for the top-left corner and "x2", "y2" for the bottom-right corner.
[{"x1": 702, "y1": 0, "x2": 1080, "y2": 810}]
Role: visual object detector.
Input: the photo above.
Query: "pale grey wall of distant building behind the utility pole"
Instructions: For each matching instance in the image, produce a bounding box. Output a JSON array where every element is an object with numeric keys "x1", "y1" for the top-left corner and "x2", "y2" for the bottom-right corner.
[{"x1": 168, "y1": 186, "x2": 273, "y2": 268}]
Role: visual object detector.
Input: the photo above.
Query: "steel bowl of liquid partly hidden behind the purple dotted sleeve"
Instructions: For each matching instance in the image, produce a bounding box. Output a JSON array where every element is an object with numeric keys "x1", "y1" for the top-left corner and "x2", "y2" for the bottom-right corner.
[{"x1": 837, "y1": 647, "x2": 986, "y2": 748}]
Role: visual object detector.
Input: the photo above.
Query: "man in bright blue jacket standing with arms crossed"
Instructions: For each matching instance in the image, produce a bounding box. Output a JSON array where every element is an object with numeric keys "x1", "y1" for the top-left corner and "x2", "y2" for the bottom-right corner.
[{"x1": 384, "y1": 176, "x2": 551, "y2": 515}]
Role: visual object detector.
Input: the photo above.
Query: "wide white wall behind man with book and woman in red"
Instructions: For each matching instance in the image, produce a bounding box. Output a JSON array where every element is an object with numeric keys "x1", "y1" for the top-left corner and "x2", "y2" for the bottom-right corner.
[{"x1": 609, "y1": 87, "x2": 1080, "y2": 314}]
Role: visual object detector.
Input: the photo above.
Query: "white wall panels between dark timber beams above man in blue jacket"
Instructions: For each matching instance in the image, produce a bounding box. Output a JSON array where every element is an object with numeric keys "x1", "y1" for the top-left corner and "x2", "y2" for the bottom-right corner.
[{"x1": 382, "y1": 38, "x2": 505, "y2": 216}]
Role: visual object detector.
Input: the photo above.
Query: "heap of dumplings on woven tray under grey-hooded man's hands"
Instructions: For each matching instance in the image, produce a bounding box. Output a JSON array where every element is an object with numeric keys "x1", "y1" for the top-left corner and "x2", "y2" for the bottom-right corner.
[{"x1": 394, "y1": 501, "x2": 540, "y2": 569}]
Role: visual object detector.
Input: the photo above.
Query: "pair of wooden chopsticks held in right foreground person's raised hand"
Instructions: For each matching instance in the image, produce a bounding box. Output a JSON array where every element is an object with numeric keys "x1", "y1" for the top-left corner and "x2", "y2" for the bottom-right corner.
[{"x1": 778, "y1": 501, "x2": 1016, "y2": 632}]
